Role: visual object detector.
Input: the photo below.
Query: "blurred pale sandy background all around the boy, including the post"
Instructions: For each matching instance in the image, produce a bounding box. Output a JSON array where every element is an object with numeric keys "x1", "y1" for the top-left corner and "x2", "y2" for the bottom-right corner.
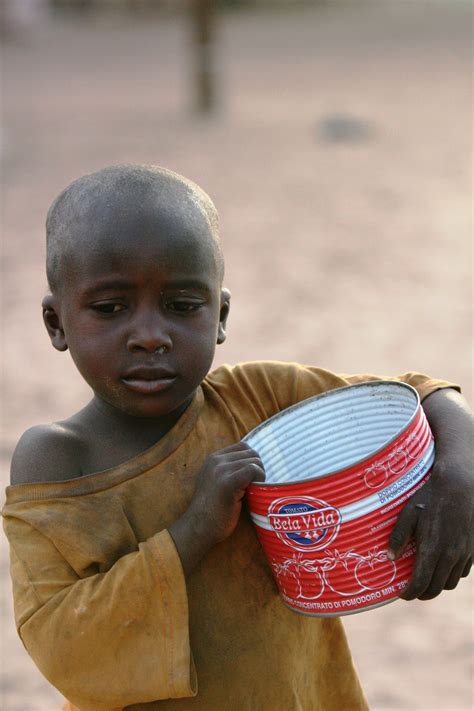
[{"x1": 0, "y1": 0, "x2": 473, "y2": 711}]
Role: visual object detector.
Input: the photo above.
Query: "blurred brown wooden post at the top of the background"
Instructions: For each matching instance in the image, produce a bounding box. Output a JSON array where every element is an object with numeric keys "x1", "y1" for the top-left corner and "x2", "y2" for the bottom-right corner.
[{"x1": 190, "y1": 0, "x2": 217, "y2": 113}]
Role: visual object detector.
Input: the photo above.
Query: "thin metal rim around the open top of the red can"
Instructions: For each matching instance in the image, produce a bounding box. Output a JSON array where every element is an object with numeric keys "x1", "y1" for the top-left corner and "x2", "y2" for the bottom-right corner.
[{"x1": 246, "y1": 380, "x2": 421, "y2": 487}]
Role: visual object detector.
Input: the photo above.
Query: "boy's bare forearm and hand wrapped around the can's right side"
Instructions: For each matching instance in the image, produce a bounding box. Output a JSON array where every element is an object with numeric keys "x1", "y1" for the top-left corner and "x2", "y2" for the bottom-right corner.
[{"x1": 390, "y1": 388, "x2": 474, "y2": 600}]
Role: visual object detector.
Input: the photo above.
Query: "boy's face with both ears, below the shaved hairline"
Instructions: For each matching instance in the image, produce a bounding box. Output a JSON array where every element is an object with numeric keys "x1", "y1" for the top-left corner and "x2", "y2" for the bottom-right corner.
[{"x1": 45, "y1": 197, "x2": 230, "y2": 417}]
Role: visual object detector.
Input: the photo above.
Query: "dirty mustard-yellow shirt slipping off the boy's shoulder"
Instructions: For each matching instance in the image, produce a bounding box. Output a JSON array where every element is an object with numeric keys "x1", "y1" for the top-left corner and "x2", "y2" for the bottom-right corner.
[{"x1": 3, "y1": 362, "x2": 456, "y2": 711}]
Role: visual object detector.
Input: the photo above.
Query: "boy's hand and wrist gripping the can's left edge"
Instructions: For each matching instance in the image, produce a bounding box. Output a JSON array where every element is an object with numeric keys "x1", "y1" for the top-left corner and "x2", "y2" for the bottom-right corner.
[{"x1": 168, "y1": 442, "x2": 265, "y2": 573}]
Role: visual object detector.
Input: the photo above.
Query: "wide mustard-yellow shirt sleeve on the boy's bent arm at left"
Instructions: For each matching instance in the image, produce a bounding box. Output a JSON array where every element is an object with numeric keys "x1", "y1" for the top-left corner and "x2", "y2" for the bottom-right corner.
[{"x1": 0, "y1": 507, "x2": 197, "y2": 711}]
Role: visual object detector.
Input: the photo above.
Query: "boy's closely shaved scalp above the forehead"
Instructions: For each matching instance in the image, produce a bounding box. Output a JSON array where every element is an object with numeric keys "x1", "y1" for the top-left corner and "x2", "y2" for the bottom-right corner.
[{"x1": 46, "y1": 165, "x2": 224, "y2": 293}]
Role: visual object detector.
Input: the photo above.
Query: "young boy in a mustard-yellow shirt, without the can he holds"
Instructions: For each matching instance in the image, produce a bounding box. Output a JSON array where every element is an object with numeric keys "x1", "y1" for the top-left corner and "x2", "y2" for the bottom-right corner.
[{"x1": 3, "y1": 166, "x2": 472, "y2": 711}]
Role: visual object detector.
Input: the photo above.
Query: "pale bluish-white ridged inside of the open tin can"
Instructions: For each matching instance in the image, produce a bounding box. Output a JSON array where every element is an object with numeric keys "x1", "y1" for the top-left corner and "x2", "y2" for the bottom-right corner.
[{"x1": 244, "y1": 381, "x2": 420, "y2": 485}]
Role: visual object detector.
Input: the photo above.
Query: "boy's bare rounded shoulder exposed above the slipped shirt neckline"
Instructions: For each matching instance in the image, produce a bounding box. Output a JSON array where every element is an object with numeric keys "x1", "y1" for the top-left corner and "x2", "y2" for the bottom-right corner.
[{"x1": 10, "y1": 420, "x2": 84, "y2": 485}]
